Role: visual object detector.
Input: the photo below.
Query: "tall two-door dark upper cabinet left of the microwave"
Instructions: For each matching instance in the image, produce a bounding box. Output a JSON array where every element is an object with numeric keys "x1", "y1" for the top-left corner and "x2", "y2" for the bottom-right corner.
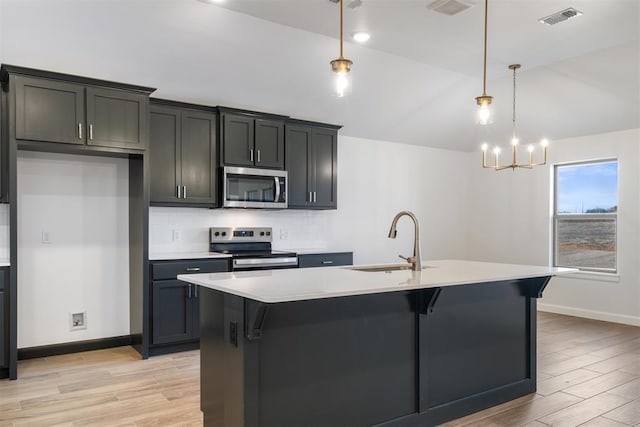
[{"x1": 149, "y1": 100, "x2": 217, "y2": 207}]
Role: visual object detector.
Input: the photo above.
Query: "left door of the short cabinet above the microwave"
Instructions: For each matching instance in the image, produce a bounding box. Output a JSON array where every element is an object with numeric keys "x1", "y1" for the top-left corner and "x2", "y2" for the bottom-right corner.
[{"x1": 222, "y1": 114, "x2": 255, "y2": 166}]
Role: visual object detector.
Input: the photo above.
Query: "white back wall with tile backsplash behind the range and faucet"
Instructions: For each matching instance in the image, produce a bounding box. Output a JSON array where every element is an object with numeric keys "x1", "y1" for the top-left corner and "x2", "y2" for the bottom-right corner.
[{"x1": 149, "y1": 136, "x2": 469, "y2": 263}]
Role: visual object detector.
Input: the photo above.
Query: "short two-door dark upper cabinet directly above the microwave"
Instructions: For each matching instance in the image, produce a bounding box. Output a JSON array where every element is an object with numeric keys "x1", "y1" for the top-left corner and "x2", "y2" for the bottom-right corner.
[{"x1": 222, "y1": 113, "x2": 284, "y2": 169}]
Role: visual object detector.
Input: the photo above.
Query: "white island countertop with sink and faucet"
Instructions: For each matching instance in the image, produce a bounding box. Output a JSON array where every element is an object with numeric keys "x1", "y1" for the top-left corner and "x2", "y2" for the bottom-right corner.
[{"x1": 178, "y1": 260, "x2": 578, "y2": 303}]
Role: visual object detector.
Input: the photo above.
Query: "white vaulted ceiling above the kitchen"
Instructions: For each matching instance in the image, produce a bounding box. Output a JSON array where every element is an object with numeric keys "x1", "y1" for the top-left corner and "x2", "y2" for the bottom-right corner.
[{"x1": 0, "y1": 0, "x2": 640, "y2": 151}]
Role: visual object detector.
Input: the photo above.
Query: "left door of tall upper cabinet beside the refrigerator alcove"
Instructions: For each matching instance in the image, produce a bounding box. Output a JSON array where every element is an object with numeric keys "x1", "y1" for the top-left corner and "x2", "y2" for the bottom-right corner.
[{"x1": 149, "y1": 105, "x2": 181, "y2": 203}]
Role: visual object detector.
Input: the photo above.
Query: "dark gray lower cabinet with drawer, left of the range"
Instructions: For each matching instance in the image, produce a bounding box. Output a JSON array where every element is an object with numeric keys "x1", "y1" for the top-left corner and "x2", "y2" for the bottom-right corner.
[{"x1": 150, "y1": 258, "x2": 230, "y2": 355}]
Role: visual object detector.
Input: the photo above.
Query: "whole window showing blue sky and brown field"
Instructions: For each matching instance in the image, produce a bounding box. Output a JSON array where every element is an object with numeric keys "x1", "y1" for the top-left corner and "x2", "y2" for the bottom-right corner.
[{"x1": 553, "y1": 160, "x2": 618, "y2": 273}]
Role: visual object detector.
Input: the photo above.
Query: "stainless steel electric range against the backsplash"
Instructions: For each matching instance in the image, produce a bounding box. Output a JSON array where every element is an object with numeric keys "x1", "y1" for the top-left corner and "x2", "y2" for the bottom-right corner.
[{"x1": 209, "y1": 227, "x2": 298, "y2": 271}]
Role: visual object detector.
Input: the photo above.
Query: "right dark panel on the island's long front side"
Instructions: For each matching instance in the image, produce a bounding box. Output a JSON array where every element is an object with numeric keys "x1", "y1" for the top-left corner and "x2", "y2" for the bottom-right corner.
[{"x1": 416, "y1": 278, "x2": 548, "y2": 425}]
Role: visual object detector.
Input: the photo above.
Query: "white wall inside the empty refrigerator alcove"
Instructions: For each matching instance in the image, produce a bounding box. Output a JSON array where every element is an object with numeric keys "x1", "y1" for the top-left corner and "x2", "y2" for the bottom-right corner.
[{"x1": 17, "y1": 152, "x2": 129, "y2": 348}]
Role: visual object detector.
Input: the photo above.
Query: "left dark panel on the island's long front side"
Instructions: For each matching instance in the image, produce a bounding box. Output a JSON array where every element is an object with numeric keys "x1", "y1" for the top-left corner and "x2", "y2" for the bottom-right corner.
[{"x1": 259, "y1": 292, "x2": 416, "y2": 427}]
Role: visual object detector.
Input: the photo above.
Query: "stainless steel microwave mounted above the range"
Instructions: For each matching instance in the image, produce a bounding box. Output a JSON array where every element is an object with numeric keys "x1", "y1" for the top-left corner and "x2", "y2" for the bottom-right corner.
[{"x1": 222, "y1": 166, "x2": 287, "y2": 209}]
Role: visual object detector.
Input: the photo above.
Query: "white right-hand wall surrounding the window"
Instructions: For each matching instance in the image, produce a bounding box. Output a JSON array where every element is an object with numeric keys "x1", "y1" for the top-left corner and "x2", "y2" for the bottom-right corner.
[{"x1": 468, "y1": 129, "x2": 640, "y2": 325}]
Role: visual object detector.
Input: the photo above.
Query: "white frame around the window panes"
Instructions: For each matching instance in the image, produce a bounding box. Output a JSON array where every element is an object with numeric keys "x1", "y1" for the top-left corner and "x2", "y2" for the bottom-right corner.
[{"x1": 551, "y1": 158, "x2": 620, "y2": 275}]
